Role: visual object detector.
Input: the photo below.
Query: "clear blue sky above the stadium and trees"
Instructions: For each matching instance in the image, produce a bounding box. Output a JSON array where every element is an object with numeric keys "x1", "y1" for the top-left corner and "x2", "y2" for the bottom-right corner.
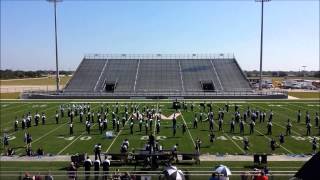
[{"x1": 1, "y1": 0, "x2": 319, "y2": 71}]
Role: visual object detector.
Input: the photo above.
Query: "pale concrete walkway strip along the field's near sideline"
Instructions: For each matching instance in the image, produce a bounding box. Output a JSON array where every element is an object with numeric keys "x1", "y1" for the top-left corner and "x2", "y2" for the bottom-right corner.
[{"x1": 0, "y1": 154, "x2": 312, "y2": 162}]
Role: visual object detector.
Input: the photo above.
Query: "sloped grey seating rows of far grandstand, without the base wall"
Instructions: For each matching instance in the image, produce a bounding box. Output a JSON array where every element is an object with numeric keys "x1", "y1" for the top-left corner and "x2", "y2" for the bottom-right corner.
[{"x1": 64, "y1": 55, "x2": 251, "y2": 93}]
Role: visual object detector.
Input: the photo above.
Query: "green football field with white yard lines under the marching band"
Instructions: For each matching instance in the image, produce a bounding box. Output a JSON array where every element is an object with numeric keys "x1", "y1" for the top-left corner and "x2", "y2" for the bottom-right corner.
[{"x1": 1, "y1": 100, "x2": 320, "y2": 155}]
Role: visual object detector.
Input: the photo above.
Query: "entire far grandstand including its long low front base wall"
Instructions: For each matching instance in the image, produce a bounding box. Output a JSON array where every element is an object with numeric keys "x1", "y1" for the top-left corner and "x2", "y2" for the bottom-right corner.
[{"x1": 22, "y1": 54, "x2": 288, "y2": 99}]
